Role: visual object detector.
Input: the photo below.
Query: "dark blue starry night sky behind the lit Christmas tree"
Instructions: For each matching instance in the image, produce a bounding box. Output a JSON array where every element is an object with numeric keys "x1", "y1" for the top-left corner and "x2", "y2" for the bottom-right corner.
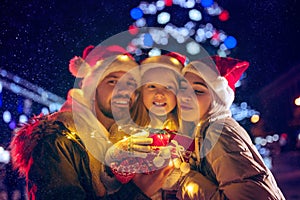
[{"x1": 0, "y1": 0, "x2": 300, "y2": 142}]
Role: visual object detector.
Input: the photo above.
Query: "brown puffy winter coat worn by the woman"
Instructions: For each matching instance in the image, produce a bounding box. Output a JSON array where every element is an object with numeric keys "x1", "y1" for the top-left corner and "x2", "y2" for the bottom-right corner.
[{"x1": 177, "y1": 117, "x2": 285, "y2": 200}]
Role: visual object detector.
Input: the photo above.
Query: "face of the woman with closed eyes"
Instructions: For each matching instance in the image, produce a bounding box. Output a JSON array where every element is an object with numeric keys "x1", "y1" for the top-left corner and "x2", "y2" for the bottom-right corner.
[{"x1": 178, "y1": 72, "x2": 212, "y2": 123}]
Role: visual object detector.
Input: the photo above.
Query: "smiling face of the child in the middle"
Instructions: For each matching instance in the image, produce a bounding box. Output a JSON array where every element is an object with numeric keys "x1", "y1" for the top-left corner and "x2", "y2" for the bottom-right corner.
[{"x1": 142, "y1": 68, "x2": 177, "y2": 116}]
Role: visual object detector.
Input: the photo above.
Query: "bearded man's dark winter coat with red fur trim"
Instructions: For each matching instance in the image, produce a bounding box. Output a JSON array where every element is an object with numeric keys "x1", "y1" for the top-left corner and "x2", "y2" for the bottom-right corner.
[{"x1": 10, "y1": 89, "x2": 149, "y2": 200}]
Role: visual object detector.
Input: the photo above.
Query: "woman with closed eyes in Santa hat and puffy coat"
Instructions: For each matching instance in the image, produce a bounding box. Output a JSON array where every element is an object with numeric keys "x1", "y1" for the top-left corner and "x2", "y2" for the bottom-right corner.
[{"x1": 177, "y1": 57, "x2": 285, "y2": 200}]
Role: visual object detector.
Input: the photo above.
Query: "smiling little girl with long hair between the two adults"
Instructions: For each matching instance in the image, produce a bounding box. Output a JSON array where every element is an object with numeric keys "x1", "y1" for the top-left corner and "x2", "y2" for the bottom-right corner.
[{"x1": 110, "y1": 55, "x2": 183, "y2": 143}]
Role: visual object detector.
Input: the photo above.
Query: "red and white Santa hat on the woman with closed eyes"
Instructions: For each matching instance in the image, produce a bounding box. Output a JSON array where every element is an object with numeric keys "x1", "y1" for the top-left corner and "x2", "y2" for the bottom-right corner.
[{"x1": 182, "y1": 56, "x2": 249, "y2": 108}]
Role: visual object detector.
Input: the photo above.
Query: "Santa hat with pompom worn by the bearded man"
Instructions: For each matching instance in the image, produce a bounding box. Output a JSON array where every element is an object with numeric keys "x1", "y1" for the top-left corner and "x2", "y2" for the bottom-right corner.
[{"x1": 69, "y1": 45, "x2": 139, "y2": 108}]
